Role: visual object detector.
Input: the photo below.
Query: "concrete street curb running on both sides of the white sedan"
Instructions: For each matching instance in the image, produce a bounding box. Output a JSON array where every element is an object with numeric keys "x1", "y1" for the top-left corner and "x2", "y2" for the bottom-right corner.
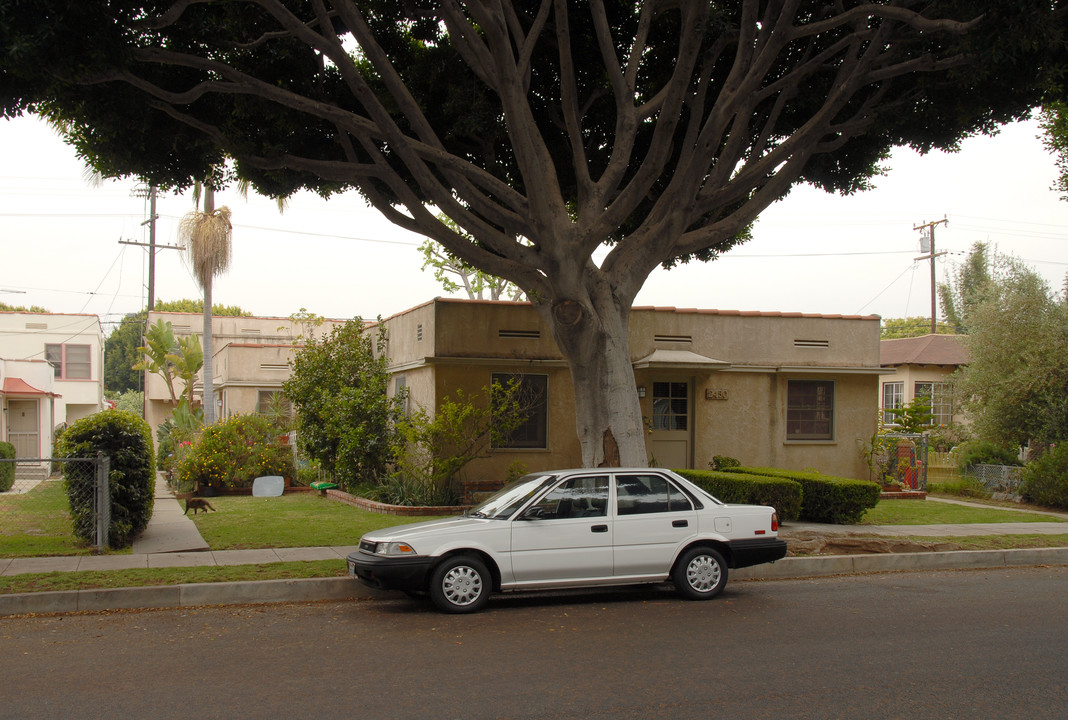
[{"x1": 0, "y1": 548, "x2": 1068, "y2": 616}]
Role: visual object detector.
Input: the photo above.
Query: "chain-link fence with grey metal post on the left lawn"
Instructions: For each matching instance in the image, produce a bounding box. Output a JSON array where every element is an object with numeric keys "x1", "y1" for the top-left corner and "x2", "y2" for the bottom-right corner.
[{"x1": 0, "y1": 453, "x2": 111, "y2": 552}]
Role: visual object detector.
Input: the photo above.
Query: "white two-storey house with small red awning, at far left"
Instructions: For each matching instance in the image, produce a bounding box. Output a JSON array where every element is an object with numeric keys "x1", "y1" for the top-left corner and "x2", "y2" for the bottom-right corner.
[{"x1": 0, "y1": 312, "x2": 104, "y2": 457}]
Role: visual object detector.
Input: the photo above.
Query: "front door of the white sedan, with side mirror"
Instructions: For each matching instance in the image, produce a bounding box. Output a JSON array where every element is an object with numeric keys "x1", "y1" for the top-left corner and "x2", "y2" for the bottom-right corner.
[{"x1": 511, "y1": 474, "x2": 612, "y2": 585}]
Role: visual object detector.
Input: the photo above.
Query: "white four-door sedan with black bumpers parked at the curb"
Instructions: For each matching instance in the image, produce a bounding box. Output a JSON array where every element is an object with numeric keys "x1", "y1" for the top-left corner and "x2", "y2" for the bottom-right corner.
[{"x1": 348, "y1": 468, "x2": 786, "y2": 612}]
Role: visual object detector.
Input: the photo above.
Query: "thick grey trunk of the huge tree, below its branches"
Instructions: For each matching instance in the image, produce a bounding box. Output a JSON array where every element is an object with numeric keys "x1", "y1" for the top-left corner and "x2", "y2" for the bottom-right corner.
[{"x1": 538, "y1": 284, "x2": 648, "y2": 468}]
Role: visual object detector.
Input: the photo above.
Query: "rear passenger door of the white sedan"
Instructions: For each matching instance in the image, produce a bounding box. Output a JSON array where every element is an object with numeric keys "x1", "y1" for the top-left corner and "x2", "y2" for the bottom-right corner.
[{"x1": 612, "y1": 472, "x2": 697, "y2": 579}]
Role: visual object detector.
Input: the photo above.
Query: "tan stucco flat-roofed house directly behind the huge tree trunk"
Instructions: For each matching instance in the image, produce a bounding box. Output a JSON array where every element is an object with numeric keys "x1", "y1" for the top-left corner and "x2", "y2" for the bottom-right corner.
[{"x1": 375, "y1": 298, "x2": 882, "y2": 481}]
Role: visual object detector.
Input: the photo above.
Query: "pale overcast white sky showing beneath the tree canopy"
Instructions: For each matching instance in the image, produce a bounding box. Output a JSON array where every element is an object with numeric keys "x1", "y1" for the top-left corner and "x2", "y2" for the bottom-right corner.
[{"x1": 0, "y1": 112, "x2": 1068, "y2": 332}]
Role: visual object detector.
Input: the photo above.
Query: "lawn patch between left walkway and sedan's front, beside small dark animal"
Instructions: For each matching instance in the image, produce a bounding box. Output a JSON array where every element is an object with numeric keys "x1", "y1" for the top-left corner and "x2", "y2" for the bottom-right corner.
[{"x1": 189, "y1": 492, "x2": 450, "y2": 550}]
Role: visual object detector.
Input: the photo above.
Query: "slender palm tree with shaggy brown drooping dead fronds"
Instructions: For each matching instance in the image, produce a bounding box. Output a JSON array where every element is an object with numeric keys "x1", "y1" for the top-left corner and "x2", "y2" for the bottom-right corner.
[{"x1": 178, "y1": 187, "x2": 233, "y2": 426}]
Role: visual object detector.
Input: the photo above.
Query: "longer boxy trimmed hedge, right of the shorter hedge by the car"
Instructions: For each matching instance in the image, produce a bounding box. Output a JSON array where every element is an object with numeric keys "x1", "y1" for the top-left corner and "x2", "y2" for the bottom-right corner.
[{"x1": 732, "y1": 467, "x2": 882, "y2": 525}]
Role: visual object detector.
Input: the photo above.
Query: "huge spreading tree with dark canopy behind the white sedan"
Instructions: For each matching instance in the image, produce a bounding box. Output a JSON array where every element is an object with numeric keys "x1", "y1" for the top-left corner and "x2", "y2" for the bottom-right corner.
[{"x1": 0, "y1": 0, "x2": 1064, "y2": 466}]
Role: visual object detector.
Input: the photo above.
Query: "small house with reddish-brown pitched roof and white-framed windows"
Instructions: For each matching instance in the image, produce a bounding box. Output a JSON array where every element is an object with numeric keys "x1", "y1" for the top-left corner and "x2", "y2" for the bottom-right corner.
[{"x1": 879, "y1": 335, "x2": 968, "y2": 425}]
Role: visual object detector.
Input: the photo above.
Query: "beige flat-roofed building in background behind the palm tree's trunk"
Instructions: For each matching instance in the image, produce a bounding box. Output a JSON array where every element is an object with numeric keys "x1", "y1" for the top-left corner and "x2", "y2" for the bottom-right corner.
[{"x1": 145, "y1": 311, "x2": 343, "y2": 432}]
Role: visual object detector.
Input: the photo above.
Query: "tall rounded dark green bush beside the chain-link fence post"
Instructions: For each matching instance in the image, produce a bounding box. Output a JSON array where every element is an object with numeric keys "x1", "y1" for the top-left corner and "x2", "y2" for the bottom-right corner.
[{"x1": 57, "y1": 410, "x2": 156, "y2": 548}]
